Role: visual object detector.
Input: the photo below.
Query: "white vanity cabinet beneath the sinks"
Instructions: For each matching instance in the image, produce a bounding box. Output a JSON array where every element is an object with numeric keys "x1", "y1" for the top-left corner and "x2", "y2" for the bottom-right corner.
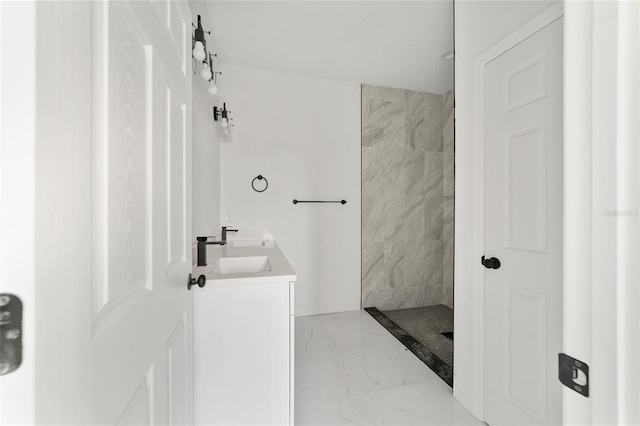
[{"x1": 192, "y1": 235, "x2": 296, "y2": 425}]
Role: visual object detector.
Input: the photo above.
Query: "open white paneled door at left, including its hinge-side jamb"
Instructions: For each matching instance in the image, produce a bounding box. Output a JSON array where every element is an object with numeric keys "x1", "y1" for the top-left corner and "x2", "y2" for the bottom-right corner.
[{"x1": 0, "y1": 0, "x2": 193, "y2": 425}]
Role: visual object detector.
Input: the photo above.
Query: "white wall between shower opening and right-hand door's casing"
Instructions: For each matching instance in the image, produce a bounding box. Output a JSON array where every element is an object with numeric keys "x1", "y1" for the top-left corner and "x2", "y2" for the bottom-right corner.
[{"x1": 453, "y1": 0, "x2": 554, "y2": 418}]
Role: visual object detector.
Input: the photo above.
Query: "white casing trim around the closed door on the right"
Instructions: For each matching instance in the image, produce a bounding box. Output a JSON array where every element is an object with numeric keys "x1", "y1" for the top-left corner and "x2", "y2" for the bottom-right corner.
[{"x1": 464, "y1": 2, "x2": 564, "y2": 420}]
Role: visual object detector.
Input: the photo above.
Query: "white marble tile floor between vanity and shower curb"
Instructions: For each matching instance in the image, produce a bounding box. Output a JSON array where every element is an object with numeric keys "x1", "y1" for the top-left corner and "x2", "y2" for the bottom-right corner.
[{"x1": 295, "y1": 311, "x2": 484, "y2": 426}]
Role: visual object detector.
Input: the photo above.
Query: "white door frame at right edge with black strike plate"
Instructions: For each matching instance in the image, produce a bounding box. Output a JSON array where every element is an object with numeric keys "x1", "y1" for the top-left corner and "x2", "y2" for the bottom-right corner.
[{"x1": 563, "y1": 1, "x2": 640, "y2": 425}]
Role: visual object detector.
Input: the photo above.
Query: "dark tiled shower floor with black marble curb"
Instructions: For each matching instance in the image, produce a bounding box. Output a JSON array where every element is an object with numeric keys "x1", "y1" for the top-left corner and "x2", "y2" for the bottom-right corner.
[{"x1": 365, "y1": 305, "x2": 453, "y2": 386}]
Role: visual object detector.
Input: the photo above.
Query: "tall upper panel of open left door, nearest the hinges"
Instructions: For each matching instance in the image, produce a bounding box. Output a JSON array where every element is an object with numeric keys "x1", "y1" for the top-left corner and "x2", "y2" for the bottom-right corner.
[{"x1": 93, "y1": 0, "x2": 153, "y2": 332}]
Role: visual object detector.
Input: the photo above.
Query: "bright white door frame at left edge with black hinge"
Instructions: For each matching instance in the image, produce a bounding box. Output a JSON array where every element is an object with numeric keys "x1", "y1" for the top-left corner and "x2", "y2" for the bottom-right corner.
[{"x1": 0, "y1": 1, "x2": 38, "y2": 425}]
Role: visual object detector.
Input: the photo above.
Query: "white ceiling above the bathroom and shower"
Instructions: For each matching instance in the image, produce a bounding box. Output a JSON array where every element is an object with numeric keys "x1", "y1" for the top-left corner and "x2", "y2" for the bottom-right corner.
[{"x1": 201, "y1": 0, "x2": 453, "y2": 94}]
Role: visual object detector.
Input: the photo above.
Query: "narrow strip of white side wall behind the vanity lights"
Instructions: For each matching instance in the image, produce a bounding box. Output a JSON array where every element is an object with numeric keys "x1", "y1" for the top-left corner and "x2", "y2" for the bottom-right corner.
[{"x1": 189, "y1": 2, "x2": 220, "y2": 243}]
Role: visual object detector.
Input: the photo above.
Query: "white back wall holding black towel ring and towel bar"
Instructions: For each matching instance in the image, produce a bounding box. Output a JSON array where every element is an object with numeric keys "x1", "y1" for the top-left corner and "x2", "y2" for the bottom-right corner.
[{"x1": 221, "y1": 65, "x2": 360, "y2": 315}]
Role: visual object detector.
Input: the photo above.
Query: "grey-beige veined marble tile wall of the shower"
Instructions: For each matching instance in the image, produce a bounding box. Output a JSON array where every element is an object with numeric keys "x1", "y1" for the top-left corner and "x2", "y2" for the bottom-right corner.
[{"x1": 362, "y1": 86, "x2": 453, "y2": 310}]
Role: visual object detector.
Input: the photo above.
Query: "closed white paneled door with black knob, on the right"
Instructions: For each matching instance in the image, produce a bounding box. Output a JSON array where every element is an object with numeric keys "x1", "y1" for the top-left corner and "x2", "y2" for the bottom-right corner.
[{"x1": 478, "y1": 19, "x2": 563, "y2": 425}]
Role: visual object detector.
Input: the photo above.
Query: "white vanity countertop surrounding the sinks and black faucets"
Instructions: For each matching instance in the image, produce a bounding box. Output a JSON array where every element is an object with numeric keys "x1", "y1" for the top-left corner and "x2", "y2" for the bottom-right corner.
[{"x1": 192, "y1": 231, "x2": 297, "y2": 286}]
